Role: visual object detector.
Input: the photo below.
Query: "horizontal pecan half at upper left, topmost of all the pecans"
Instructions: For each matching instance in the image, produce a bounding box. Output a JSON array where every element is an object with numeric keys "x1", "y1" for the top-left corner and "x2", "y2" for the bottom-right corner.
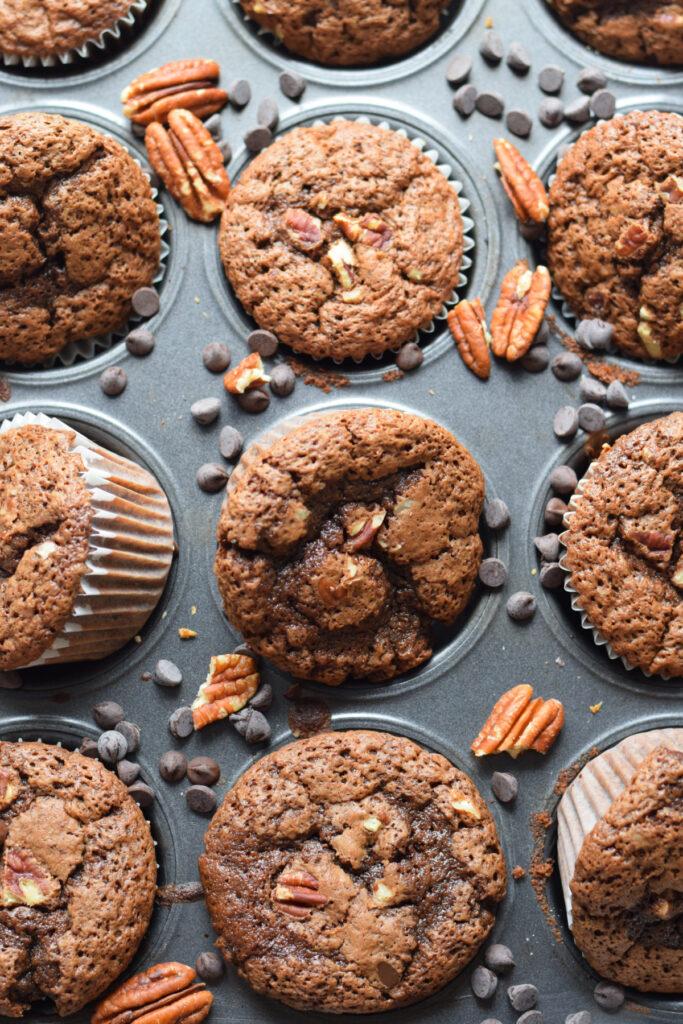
[{"x1": 121, "y1": 60, "x2": 227, "y2": 125}]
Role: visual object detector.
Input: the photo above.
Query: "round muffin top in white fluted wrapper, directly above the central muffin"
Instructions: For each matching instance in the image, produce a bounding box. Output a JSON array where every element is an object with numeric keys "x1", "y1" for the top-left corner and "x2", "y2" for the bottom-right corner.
[{"x1": 218, "y1": 120, "x2": 463, "y2": 359}]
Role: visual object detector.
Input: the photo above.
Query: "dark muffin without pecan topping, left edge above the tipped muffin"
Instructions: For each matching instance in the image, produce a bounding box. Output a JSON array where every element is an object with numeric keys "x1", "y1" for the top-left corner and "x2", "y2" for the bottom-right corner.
[{"x1": 0, "y1": 113, "x2": 161, "y2": 364}]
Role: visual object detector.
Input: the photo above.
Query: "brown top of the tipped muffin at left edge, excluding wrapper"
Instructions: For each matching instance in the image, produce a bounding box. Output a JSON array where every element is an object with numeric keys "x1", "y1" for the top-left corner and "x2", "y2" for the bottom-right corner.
[{"x1": 0, "y1": 426, "x2": 92, "y2": 671}]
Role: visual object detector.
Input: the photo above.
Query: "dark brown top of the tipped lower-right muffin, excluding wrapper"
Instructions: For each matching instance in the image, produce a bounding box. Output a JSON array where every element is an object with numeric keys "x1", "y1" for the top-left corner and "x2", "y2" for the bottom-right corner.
[{"x1": 571, "y1": 746, "x2": 683, "y2": 994}]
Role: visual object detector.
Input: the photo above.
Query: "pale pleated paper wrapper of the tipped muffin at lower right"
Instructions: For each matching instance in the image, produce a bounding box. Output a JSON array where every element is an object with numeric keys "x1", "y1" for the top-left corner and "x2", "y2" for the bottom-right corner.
[{"x1": 557, "y1": 729, "x2": 683, "y2": 926}]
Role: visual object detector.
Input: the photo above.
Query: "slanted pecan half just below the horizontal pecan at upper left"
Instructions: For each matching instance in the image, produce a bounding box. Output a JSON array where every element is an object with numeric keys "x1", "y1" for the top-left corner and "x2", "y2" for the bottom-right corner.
[{"x1": 144, "y1": 110, "x2": 230, "y2": 223}]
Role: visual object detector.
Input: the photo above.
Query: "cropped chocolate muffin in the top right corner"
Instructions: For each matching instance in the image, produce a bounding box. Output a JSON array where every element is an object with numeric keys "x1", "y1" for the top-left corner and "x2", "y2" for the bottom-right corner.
[{"x1": 549, "y1": 0, "x2": 683, "y2": 65}]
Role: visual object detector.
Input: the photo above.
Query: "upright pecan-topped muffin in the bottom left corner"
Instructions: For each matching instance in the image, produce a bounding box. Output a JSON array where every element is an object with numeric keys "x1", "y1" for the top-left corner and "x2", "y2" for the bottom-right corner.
[{"x1": 0, "y1": 742, "x2": 157, "y2": 1017}]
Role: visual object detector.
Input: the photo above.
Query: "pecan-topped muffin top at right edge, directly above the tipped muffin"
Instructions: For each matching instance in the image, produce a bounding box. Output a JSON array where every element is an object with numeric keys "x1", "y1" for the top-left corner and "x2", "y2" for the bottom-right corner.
[{"x1": 562, "y1": 413, "x2": 683, "y2": 678}]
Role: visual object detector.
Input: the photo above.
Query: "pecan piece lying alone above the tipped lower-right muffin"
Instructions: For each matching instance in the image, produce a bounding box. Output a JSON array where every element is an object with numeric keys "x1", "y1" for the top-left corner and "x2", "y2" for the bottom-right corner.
[{"x1": 471, "y1": 684, "x2": 564, "y2": 758}]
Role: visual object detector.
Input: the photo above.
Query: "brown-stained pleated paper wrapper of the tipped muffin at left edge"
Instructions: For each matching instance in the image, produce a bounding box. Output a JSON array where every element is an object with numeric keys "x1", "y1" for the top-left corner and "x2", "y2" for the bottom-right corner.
[{"x1": 0, "y1": 413, "x2": 174, "y2": 668}]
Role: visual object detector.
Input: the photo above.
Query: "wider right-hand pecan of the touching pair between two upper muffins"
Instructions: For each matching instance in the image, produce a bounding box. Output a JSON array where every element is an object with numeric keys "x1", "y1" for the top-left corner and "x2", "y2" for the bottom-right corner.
[{"x1": 490, "y1": 260, "x2": 551, "y2": 362}]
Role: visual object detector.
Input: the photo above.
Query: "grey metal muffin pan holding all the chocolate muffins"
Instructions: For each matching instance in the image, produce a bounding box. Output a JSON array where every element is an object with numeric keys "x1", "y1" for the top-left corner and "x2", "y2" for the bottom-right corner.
[{"x1": 0, "y1": 0, "x2": 683, "y2": 1024}]
